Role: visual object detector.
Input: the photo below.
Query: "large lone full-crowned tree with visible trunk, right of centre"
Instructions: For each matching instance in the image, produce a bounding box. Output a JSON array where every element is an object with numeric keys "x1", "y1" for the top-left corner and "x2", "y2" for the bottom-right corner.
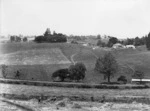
[{"x1": 95, "y1": 52, "x2": 118, "y2": 82}]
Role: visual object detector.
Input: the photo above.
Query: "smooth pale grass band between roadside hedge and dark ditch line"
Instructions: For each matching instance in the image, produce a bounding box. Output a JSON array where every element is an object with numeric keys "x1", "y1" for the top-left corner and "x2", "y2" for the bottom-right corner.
[{"x1": 0, "y1": 83, "x2": 150, "y2": 103}]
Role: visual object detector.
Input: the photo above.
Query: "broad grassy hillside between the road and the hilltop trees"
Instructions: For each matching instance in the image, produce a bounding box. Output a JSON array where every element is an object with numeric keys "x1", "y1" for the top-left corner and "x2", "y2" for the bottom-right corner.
[{"x1": 0, "y1": 42, "x2": 150, "y2": 83}]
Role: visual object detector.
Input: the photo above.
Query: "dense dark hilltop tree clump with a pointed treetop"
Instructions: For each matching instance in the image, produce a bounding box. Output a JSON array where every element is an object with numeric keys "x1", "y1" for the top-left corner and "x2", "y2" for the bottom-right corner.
[{"x1": 34, "y1": 28, "x2": 67, "y2": 43}]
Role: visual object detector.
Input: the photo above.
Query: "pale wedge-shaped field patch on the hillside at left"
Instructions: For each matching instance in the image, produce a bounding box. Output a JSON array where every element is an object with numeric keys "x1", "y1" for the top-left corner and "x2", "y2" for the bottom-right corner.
[{"x1": 0, "y1": 48, "x2": 71, "y2": 65}]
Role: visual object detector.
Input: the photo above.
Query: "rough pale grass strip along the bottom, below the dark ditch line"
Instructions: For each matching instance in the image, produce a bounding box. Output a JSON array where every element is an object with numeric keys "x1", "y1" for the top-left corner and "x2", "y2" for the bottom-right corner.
[{"x1": 0, "y1": 98, "x2": 150, "y2": 111}]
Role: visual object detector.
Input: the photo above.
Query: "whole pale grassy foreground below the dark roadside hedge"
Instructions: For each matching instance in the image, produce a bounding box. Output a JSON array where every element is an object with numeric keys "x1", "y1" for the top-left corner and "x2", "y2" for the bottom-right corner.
[{"x1": 0, "y1": 83, "x2": 150, "y2": 111}]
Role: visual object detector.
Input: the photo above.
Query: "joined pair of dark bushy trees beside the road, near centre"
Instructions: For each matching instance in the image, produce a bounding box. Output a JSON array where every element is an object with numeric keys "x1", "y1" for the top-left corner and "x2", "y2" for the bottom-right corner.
[{"x1": 52, "y1": 63, "x2": 86, "y2": 81}]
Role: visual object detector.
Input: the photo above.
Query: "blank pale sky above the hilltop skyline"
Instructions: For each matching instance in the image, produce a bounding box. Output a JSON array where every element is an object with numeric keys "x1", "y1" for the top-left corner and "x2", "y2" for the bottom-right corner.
[{"x1": 0, "y1": 0, "x2": 150, "y2": 38}]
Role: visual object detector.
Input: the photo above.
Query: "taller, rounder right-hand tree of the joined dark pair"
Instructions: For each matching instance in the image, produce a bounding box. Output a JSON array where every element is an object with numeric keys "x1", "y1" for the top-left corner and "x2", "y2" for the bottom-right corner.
[{"x1": 69, "y1": 62, "x2": 86, "y2": 81}]
